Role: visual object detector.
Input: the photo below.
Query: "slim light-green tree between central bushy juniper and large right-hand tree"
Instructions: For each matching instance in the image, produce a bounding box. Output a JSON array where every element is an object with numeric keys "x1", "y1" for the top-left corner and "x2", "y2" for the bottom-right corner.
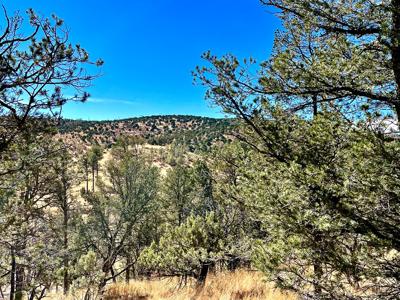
[{"x1": 208, "y1": 142, "x2": 266, "y2": 270}]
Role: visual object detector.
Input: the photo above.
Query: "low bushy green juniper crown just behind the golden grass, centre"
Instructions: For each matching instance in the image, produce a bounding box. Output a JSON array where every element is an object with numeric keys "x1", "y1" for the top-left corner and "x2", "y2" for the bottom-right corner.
[{"x1": 139, "y1": 213, "x2": 225, "y2": 278}]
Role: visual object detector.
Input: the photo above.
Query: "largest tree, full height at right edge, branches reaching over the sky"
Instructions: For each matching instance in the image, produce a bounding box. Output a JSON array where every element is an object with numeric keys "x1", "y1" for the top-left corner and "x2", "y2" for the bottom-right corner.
[{"x1": 195, "y1": 0, "x2": 400, "y2": 299}]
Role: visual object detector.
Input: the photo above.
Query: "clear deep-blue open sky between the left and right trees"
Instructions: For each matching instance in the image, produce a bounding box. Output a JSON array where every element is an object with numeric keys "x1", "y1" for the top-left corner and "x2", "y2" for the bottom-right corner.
[{"x1": 1, "y1": 0, "x2": 279, "y2": 120}]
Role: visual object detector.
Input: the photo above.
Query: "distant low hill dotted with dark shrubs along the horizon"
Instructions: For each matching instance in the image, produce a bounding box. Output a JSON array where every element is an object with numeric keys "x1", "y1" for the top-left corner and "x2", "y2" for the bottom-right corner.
[{"x1": 59, "y1": 115, "x2": 235, "y2": 152}]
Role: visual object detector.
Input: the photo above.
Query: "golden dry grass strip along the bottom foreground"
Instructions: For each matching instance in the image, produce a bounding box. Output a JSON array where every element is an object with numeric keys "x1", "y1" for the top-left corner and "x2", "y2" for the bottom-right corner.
[{"x1": 105, "y1": 271, "x2": 297, "y2": 300}]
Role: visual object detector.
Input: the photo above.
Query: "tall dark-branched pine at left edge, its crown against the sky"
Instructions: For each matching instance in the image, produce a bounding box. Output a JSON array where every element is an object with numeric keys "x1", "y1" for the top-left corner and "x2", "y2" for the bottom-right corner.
[{"x1": 0, "y1": 5, "x2": 102, "y2": 299}]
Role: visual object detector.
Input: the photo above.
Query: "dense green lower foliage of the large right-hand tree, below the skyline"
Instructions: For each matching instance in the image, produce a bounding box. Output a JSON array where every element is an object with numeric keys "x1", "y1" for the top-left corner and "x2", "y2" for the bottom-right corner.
[{"x1": 206, "y1": 108, "x2": 399, "y2": 299}]
